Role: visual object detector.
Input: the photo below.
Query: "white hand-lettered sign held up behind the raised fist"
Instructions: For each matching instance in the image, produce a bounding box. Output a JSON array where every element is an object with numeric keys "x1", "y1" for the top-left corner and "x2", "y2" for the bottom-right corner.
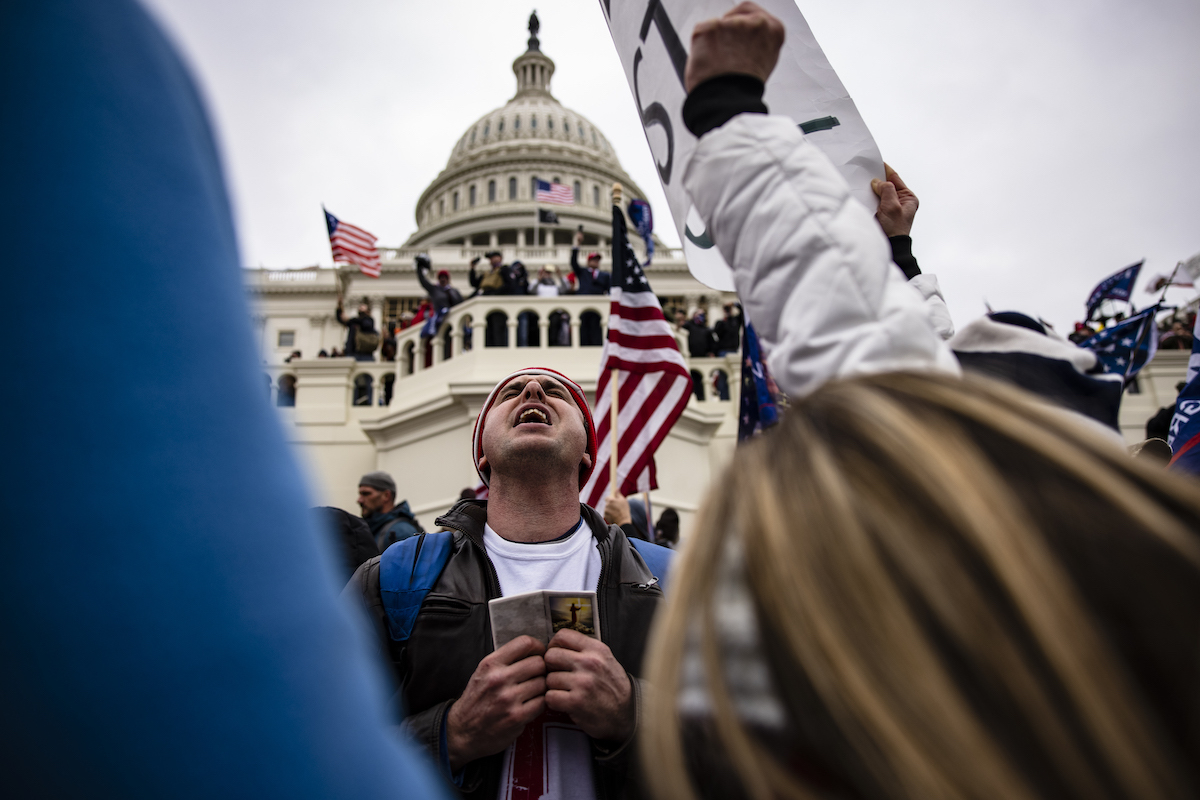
[{"x1": 600, "y1": 0, "x2": 883, "y2": 291}]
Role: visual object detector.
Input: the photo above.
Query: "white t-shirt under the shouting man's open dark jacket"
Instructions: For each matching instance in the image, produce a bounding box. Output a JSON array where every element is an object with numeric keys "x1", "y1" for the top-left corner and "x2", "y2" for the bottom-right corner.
[{"x1": 484, "y1": 519, "x2": 600, "y2": 800}]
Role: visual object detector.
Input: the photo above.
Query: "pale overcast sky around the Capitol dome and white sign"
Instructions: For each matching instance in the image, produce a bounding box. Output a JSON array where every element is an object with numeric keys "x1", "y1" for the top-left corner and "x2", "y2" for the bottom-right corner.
[{"x1": 136, "y1": 0, "x2": 1200, "y2": 331}]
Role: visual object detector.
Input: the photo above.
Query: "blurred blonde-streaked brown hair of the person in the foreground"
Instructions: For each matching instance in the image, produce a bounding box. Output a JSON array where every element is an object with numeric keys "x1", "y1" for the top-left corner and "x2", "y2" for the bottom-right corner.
[{"x1": 642, "y1": 373, "x2": 1200, "y2": 800}]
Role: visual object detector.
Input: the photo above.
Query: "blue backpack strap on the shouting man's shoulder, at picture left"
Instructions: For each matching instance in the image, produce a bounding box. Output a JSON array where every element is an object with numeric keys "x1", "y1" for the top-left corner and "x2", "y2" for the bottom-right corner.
[{"x1": 379, "y1": 531, "x2": 454, "y2": 642}]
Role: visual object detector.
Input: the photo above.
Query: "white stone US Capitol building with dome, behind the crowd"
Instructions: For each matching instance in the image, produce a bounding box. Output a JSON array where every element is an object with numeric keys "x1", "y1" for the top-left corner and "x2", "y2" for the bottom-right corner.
[{"x1": 246, "y1": 17, "x2": 1188, "y2": 535}]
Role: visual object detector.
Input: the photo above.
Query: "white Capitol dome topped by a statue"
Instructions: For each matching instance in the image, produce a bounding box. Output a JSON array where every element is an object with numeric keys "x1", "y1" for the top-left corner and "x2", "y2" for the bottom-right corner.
[{"x1": 404, "y1": 14, "x2": 646, "y2": 248}]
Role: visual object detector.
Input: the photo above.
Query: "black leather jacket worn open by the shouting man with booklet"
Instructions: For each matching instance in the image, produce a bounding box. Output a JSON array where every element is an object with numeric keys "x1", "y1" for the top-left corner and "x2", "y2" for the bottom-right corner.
[{"x1": 346, "y1": 500, "x2": 662, "y2": 800}]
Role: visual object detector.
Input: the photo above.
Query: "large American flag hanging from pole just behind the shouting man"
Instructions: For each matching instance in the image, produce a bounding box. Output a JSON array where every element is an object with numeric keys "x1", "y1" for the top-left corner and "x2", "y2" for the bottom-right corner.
[{"x1": 580, "y1": 205, "x2": 691, "y2": 511}]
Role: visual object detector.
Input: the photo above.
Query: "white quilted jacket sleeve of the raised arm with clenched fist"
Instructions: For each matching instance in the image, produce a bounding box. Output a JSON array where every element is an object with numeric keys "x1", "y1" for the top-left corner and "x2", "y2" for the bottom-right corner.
[{"x1": 684, "y1": 114, "x2": 959, "y2": 397}]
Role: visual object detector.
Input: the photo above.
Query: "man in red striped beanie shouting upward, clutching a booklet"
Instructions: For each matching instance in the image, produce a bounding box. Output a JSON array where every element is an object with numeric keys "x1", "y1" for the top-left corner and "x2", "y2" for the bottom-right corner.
[{"x1": 347, "y1": 367, "x2": 662, "y2": 800}]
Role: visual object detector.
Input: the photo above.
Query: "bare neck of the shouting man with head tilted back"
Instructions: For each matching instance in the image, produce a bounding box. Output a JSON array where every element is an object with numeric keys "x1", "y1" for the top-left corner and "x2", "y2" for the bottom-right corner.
[{"x1": 487, "y1": 475, "x2": 580, "y2": 543}]
